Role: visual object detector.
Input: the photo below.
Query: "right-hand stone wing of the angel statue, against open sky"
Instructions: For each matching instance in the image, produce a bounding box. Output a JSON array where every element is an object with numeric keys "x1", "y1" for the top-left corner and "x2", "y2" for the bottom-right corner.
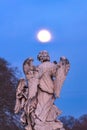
[{"x1": 54, "y1": 57, "x2": 70, "y2": 97}]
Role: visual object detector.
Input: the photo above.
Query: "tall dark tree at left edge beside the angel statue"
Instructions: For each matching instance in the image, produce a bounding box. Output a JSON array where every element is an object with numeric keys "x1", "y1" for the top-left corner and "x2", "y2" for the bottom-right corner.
[{"x1": 0, "y1": 58, "x2": 22, "y2": 130}]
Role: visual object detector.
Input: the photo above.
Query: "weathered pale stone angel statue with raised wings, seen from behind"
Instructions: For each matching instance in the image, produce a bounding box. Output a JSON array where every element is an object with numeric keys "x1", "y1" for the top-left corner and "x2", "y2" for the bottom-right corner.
[{"x1": 15, "y1": 50, "x2": 70, "y2": 130}]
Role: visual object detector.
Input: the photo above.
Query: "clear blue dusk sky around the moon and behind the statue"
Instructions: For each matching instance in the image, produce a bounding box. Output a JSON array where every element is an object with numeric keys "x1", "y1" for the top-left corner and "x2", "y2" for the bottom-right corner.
[{"x1": 0, "y1": 0, "x2": 87, "y2": 117}]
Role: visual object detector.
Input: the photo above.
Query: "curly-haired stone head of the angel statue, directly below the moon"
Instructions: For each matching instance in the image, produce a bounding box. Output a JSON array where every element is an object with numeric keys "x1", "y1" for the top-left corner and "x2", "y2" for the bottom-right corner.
[{"x1": 37, "y1": 50, "x2": 50, "y2": 62}]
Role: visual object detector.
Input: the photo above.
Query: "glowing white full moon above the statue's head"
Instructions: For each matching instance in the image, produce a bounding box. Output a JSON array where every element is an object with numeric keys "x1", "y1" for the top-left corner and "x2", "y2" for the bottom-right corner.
[{"x1": 37, "y1": 29, "x2": 52, "y2": 43}]
